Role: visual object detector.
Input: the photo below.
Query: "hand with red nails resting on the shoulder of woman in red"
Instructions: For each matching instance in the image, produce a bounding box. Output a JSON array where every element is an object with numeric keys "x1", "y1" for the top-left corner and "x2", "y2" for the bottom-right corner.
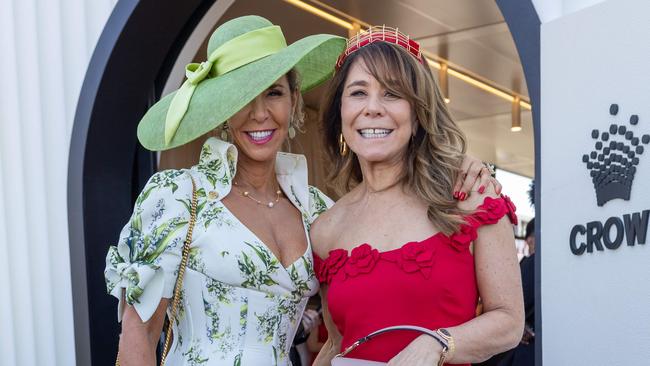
[{"x1": 453, "y1": 155, "x2": 502, "y2": 201}]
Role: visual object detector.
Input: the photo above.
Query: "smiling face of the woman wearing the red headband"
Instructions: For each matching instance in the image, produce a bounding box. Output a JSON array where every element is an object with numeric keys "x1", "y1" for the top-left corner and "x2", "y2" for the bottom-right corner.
[{"x1": 341, "y1": 58, "x2": 415, "y2": 162}]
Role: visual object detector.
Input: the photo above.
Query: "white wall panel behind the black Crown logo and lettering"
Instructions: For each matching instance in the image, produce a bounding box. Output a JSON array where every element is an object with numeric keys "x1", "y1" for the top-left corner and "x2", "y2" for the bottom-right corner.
[{"x1": 540, "y1": 0, "x2": 650, "y2": 366}]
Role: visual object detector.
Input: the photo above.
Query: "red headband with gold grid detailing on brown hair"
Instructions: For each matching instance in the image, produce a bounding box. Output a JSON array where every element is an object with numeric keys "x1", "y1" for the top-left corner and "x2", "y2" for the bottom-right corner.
[{"x1": 336, "y1": 25, "x2": 426, "y2": 70}]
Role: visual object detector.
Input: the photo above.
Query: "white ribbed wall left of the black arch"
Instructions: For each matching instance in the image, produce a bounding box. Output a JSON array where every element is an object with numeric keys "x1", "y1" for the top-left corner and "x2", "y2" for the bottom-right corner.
[{"x1": 0, "y1": 0, "x2": 116, "y2": 366}]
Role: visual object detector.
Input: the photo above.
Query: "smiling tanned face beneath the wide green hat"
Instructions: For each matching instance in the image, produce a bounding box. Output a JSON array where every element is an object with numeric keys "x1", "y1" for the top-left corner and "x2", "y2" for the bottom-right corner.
[{"x1": 228, "y1": 76, "x2": 297, "y2": 162}]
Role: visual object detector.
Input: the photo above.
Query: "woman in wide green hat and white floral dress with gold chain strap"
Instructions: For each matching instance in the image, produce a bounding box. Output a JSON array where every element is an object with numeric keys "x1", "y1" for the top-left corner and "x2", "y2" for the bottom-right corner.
[{"x1": 105, "y1": 16, "x2": 494, "y2": 366}]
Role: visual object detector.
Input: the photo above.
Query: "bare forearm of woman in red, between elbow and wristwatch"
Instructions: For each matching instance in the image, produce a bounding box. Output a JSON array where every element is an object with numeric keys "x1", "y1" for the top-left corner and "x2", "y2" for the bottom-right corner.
[{"x1": 446, "y1": 309, "x2": 524, "y2": 364}]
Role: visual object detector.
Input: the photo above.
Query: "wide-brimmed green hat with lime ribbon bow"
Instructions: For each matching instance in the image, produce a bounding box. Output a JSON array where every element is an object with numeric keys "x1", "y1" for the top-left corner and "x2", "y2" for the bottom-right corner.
[{"x1": 138, "y1": 16, "x2": 345, "y2": 151}]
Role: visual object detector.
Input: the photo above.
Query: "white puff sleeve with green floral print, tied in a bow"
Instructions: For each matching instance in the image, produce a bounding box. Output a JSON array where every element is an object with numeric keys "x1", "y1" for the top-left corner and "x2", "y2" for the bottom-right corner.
[{"x1": 104, "y1": 170, "x2": 192, "y2": 322}]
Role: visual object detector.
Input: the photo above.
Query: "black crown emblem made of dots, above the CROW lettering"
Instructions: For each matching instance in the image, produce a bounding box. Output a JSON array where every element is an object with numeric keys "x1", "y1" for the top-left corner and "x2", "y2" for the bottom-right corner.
[{"x1": 582, "y1": 104, "x2": 650, "y2": 206}]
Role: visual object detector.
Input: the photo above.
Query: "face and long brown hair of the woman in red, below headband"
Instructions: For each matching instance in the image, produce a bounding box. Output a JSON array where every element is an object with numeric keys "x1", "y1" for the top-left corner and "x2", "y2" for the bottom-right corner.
[{"x1": 320, "y1": 42, "x2": 465, "y2": 234}]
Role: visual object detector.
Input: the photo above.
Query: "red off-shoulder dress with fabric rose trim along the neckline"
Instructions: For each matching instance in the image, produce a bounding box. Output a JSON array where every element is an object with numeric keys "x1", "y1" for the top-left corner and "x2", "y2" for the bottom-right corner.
[{"x1": 314, "y1": 196, "x2": 517, "y2": 362}]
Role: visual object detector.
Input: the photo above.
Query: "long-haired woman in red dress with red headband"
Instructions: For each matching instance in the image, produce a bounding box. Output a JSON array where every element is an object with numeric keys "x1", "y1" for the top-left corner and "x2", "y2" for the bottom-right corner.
[{"x1": 311, "y1": 27, "x2": 524, "y2": 366}]
